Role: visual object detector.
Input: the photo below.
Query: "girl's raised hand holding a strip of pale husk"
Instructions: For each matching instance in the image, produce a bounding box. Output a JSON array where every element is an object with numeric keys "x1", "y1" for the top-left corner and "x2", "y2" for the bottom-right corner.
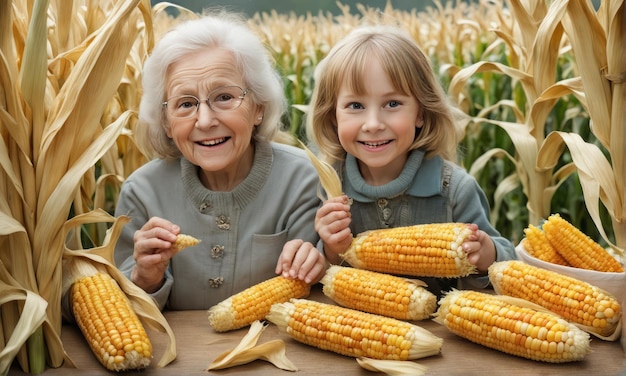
[{"x1": 315, "y1": 195, "x2": 352, "y2": 264}]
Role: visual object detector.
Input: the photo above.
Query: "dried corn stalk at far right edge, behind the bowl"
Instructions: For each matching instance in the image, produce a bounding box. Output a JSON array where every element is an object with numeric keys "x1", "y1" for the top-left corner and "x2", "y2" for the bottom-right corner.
[{"x1": 537, "y1": 0, "x2": 626, "y2": 258}]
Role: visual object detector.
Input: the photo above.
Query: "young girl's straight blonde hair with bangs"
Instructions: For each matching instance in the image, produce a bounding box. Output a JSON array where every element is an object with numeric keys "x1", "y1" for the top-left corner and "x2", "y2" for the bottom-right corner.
[{"x1": 307, "y1": 25, "x2": 457, "y2": 166}]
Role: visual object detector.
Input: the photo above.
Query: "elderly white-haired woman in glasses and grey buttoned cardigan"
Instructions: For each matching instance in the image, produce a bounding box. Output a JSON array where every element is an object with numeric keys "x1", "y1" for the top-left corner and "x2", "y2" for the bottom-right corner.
[{"x1": 115, "y1": 12, "x2": 326, "y2": 309}]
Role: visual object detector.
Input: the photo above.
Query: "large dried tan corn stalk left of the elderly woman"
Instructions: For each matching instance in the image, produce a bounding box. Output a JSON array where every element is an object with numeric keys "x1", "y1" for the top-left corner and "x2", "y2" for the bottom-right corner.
[{"x1": 0, "y1": 0, "x2": 163, "y2": 374}]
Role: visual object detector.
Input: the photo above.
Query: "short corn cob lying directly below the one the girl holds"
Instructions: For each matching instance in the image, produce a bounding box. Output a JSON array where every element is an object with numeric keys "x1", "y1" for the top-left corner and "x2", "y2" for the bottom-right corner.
[{"x1": 321, "y1": 265, "x2": 437, "y2": 320}]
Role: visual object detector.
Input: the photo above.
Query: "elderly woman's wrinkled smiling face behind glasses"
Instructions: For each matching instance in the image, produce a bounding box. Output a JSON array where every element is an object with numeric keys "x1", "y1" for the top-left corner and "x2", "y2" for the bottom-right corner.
[{"x1": 166, "y1": 48, "x2": 262, "y2": 180}]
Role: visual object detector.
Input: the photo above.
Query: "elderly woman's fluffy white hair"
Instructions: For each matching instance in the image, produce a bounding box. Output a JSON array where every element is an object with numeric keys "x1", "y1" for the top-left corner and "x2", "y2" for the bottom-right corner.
[{"x1": 137, "y1": 9, "x2": 287, "y2": 157}]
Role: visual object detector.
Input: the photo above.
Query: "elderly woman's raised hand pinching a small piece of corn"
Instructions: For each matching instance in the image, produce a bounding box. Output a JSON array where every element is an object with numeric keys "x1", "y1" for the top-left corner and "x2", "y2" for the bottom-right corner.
[{"x1": 130, "y1": 217, "x2": 180, "y2": 293}]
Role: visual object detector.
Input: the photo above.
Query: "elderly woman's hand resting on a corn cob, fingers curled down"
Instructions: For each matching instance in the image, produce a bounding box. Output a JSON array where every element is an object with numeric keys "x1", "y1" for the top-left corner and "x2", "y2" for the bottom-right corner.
[{"x1": 276, "y1": 239, "x2": 328, "y2": 285}]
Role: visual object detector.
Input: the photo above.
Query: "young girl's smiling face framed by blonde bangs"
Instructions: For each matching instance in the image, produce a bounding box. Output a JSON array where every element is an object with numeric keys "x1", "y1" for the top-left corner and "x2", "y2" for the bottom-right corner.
[{"x1": 335, "y1": 58, "x2": 423, "y2": 185}]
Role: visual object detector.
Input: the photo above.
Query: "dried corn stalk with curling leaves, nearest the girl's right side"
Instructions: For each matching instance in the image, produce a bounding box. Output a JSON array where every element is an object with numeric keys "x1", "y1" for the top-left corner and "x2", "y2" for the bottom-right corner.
[{"x1": 449, "y1": 0, "x2": 564, "y2": 228}]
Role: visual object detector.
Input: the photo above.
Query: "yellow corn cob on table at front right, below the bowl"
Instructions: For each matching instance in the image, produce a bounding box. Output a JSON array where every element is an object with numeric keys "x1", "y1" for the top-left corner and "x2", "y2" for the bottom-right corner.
[{"x1": 436, "y1": 290, "x2": 590, "y2": 363}]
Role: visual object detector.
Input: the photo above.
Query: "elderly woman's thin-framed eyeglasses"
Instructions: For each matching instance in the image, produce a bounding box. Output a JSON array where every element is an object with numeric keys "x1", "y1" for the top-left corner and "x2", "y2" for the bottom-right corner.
[{"x1": 162, "y1": 86, "x2": 250, "y2": 119}]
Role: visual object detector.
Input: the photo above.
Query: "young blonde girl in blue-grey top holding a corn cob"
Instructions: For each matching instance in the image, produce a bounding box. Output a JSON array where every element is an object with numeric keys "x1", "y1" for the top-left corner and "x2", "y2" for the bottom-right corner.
[{"x1": 307, "y1": 26, "x2": 515, "y2": 295}]
